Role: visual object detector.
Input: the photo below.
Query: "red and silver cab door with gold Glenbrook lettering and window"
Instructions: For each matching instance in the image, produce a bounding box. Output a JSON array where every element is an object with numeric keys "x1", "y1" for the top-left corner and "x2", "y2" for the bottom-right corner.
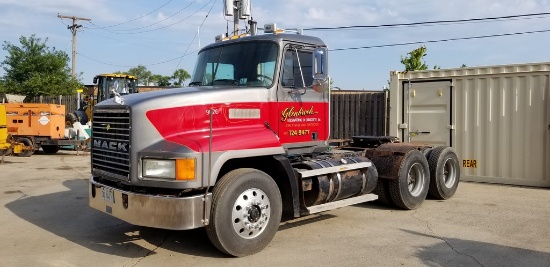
[{"x1": 277, "y1": 45, "x2": 329, "y2": 146}]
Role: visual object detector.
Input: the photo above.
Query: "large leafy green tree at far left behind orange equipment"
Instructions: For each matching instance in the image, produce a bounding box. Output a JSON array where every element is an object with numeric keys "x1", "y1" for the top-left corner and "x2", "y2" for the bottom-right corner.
[{"x1": 2, "y1": 34, "x2": 83, "y2": 97}]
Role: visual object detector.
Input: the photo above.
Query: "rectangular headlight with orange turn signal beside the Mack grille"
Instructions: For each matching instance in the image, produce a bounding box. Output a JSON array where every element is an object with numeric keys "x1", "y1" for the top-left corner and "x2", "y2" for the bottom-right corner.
[{"x1": 142, "y1": 158, "x2": 195, "y2": 181}]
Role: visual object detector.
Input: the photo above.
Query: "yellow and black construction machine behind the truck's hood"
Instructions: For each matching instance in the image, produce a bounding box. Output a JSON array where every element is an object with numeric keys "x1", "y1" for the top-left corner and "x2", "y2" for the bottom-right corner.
[{"x1": 66, "y1": 73, "x2": 138, "y2": 126}]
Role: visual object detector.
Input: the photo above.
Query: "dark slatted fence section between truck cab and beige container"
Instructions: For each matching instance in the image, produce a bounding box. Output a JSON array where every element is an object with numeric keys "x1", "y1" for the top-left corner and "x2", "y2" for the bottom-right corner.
[{"x1": 330, "y1": 91, "x2": 389, "y2": 139}]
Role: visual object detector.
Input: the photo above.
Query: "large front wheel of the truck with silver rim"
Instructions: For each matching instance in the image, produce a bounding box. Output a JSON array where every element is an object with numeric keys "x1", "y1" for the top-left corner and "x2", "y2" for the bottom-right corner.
[{"x1": 206, "y1": 169, "x2": 282, "y2": 257}]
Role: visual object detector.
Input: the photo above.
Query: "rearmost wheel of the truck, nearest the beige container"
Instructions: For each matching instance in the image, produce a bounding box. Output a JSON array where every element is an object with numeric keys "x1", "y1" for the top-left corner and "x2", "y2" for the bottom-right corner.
[{"x1": 428, "y1": 146, "x2": 460, "y2": 199}]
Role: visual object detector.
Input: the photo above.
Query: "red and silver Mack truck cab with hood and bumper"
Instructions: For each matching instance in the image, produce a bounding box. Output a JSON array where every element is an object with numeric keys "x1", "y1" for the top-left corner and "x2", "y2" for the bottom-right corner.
[{"x1": 90, "y1": 34, "x2": 336, "y2": 229}]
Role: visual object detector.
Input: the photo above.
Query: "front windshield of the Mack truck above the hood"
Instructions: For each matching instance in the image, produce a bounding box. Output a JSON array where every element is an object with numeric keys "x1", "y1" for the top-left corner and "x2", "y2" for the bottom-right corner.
[{"x1": 193, "y1": 42, "x2": 278, "y2": 87}]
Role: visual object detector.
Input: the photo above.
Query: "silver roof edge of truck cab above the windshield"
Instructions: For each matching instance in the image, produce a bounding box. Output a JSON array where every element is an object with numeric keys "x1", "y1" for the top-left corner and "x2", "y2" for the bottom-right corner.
[{"x1": 201, "y1": 33, "x2": 326, "y2": 51}]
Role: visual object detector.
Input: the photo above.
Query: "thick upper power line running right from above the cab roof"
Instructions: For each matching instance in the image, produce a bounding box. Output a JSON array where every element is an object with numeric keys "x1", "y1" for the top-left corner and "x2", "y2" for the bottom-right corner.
[{"x1": 304, "y1": 12, "x2": 550, "y2": 31}]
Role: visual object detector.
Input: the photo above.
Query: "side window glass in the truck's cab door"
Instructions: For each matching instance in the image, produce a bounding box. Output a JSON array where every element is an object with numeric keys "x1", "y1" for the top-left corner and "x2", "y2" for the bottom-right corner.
[{"x1": 281, "y1": 50, "x2": 313, "y2": 88}]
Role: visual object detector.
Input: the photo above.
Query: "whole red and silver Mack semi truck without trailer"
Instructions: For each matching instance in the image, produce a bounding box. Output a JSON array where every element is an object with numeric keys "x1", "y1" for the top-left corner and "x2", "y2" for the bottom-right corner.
[{"x1": 89, "y1": 25, "x2": 460, "y2": 257}]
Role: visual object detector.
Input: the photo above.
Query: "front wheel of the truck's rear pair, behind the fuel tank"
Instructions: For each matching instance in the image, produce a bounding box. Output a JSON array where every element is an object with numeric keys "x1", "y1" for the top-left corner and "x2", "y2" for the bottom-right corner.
[{"x1": 389, "y1": 150, "x2": 430, "y2": 210}]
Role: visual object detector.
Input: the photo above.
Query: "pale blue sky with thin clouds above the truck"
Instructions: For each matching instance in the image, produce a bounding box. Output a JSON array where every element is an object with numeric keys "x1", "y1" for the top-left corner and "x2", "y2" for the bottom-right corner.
[{"x1": 0, "y1": 0, "x2": 550, "y2": 90}]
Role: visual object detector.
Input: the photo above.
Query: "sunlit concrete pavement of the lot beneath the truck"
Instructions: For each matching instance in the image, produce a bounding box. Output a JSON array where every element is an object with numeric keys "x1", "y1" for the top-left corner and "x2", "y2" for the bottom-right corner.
[{"x1": 0, "y1": 150, "x2": 550, "y2": 267}]
